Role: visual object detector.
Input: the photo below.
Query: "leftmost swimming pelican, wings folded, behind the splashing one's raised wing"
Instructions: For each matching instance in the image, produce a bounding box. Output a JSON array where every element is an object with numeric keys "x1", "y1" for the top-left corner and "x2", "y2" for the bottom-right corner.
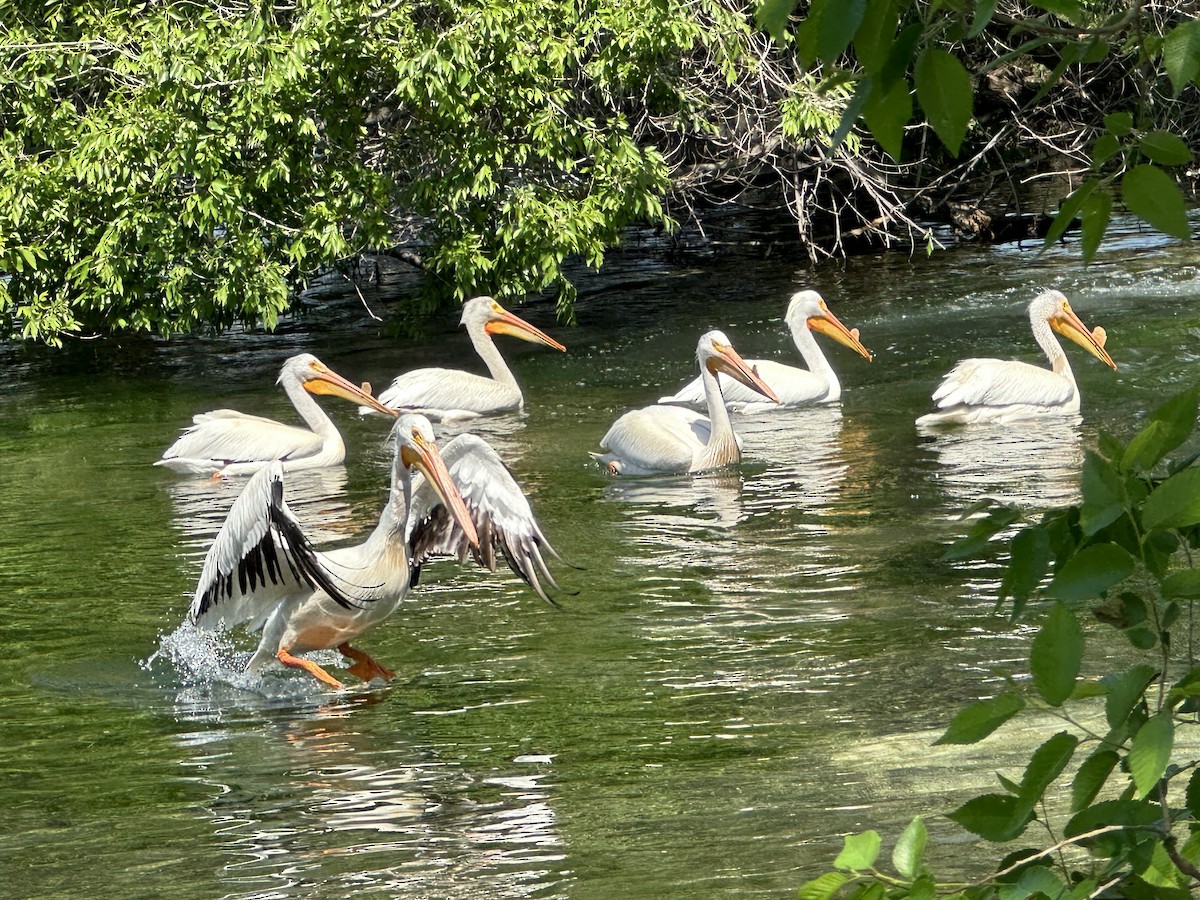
[{"x1": 155, "y1": 353, "x2": 396, "y2": 476}]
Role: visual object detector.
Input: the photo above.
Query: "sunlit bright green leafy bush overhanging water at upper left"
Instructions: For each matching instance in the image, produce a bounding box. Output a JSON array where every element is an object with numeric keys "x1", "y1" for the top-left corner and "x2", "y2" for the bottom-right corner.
[{"x1": 0, "y1": 0, "x2": 739, "y2": 342}]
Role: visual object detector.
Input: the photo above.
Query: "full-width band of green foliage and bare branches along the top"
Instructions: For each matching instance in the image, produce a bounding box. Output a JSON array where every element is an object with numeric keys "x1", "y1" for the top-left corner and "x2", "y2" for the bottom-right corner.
[{"x1": 0, "y1": 0, "x2": 1200, "y2": 343}]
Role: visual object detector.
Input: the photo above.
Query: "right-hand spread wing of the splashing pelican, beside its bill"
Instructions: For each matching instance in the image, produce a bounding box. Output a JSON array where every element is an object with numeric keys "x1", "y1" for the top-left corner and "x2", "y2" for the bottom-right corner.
[{"x1": 408, "y1": 434, "x2": 558, "y2": 604}]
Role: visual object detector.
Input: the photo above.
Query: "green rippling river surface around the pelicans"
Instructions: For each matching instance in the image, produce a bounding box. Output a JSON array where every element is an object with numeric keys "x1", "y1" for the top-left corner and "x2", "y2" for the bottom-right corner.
[{"x1": 0, "y1": 222, "x2": 1200, "y2": 900}]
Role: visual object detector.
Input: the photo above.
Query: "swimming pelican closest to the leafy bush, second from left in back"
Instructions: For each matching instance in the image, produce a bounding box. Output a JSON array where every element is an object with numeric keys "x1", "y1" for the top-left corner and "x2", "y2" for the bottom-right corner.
[{"x1": 374, "y1": 296, "x2": 566, "y2": 421}]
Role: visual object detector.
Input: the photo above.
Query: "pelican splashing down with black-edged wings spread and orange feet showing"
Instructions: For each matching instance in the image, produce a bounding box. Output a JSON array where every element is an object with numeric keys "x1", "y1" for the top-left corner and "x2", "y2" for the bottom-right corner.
[{"x1": 190, "y1": 415, "x2": 558, "y2": 689}]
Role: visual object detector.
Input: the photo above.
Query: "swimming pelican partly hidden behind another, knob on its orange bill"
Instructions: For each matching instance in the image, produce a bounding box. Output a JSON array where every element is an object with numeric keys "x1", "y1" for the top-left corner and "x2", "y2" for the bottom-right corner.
[{"x1": 659, "y1": 290, "x2": 871, "y2": 413}]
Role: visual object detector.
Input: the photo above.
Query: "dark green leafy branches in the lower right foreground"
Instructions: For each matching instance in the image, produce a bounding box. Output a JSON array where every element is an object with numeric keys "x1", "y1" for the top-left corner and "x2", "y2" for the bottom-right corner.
[{"x1": 800, "y1": 388, "x2": 1200, "y2": 900}]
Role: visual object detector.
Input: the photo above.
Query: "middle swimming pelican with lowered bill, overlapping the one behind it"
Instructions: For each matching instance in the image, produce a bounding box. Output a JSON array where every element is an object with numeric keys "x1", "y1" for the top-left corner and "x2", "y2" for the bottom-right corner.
[{"x1": 592, "y1": 331, "x2": 779, "y2": 475}]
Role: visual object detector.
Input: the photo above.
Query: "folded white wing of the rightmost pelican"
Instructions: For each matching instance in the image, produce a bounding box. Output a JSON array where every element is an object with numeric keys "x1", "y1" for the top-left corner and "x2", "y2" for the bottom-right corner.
[{"x1": 934, "y1": 359, "x2": 1074, "y2": 409}]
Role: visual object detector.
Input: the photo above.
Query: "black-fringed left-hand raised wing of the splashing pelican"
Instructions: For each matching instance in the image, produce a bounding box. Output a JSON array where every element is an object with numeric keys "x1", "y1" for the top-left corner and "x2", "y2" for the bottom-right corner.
[{"x1": 190, "y1": 462, "x2": 358, "y2": 630}]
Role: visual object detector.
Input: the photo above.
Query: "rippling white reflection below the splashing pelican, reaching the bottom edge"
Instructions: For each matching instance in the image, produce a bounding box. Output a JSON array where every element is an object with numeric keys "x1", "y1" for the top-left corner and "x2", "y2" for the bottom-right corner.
[{"x1": 166, "y1": 698, "x2": 565, "y2": 898}]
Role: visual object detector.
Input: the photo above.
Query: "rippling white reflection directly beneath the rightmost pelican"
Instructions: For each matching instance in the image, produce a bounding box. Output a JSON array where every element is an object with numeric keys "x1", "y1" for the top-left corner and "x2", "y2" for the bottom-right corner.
[{"x1": 924, "y1": 415, "x2": 1084, "y2": 509}]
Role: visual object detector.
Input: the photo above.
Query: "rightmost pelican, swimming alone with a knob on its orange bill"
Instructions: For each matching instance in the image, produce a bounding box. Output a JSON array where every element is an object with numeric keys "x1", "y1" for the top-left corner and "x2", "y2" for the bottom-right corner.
[{"x1": 917, "y1": 290, "x2": 1117, "y2": 426}]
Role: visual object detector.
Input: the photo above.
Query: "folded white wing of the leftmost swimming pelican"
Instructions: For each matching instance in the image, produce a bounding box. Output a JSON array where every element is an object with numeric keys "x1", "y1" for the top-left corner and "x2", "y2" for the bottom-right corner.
[{"x1": 162, "y1": 409, "x2": 322, "y2": 463}]
